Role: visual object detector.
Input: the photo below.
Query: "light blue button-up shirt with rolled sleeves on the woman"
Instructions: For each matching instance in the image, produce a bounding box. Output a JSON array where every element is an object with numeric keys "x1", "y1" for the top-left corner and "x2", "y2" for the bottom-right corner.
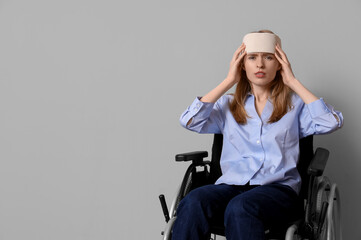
[{"x1": 180, "y1": 94, "x2": 343, "y2": 193}]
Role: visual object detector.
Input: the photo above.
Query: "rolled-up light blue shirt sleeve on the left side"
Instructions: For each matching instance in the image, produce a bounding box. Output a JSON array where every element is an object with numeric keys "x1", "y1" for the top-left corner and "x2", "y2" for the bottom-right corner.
[{"x1": 179, "y1": 97, "x2": 223, "y2": 133}]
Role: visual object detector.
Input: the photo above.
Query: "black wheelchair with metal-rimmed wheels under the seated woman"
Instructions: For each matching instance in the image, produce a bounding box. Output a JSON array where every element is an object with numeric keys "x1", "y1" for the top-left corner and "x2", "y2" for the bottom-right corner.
[{"x1": 159, "y1": 134, "x2": 342, "y2": 240}]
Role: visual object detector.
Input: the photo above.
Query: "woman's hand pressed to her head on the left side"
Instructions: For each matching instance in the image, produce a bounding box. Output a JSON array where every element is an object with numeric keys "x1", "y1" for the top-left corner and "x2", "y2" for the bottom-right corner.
[{"x1": 226, "y1": 43, "x2": 247, "y2": 85}]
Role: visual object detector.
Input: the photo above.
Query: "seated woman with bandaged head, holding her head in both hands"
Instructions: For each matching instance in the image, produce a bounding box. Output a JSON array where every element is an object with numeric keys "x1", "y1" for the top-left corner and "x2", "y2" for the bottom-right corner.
[{"x1": 172, "y1": 30, "x2": 343, "y2": 240}]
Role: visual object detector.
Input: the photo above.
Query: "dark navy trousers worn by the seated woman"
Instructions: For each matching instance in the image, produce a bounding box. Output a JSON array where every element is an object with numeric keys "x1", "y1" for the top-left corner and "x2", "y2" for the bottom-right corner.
[{"x1": 172, "y1": 184, "x2": 303, "y2": 240}]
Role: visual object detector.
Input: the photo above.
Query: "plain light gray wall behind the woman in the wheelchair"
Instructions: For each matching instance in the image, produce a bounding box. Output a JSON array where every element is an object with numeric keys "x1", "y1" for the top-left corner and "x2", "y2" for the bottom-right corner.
[{"x1": 0, "y1": 0, "x2": 361, "y2": 240}]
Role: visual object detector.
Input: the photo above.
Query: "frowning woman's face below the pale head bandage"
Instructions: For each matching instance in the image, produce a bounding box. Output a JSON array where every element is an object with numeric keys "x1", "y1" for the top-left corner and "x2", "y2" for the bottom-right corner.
[{"x1": 243, "y1": 52, "x2": 281, "y2": 87}]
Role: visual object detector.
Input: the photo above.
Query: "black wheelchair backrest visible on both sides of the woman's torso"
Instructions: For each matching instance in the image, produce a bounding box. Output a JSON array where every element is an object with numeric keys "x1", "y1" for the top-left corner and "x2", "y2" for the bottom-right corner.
[{"x1": 209, "y1": 134, "x2": 314, "y2": 199}]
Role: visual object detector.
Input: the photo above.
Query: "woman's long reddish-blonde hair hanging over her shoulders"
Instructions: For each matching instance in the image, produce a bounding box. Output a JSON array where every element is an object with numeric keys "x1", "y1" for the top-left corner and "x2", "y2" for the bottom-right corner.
[{"x1": 229, "y1": 30, "x2": 292, "y2": 124}]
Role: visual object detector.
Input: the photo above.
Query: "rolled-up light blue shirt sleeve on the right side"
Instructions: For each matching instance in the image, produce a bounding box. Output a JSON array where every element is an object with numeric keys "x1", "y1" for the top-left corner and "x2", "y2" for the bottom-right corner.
[{"x1": 299, "y1": 98, "x2": 343, "y2": 138}]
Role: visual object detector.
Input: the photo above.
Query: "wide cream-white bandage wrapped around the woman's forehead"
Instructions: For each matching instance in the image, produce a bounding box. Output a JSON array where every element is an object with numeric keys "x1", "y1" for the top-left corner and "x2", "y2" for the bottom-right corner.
[{"x1": 243, "y1": 33, "x2": 281, "y2": 54}]
